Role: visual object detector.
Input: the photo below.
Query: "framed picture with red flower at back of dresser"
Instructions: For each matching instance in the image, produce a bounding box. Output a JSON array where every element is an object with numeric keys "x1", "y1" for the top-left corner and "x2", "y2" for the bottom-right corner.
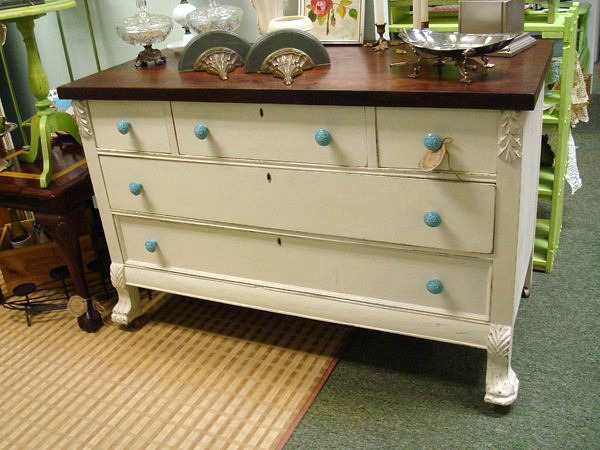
[{"x1": 298, "y1": 0, "x2": 365, "y2": 44}]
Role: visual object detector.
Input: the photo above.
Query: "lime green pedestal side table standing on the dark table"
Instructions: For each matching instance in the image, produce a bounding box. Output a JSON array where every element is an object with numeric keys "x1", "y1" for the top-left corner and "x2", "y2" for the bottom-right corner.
[{"x1": 0, "y1": 0, "x2": 81, "y2": 188}]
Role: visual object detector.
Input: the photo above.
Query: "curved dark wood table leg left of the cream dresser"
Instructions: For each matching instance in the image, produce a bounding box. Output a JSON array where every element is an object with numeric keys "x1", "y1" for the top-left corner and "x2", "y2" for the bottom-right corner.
[{"x1": 35, "y1": 208, "x2": 102, "y2": 333}]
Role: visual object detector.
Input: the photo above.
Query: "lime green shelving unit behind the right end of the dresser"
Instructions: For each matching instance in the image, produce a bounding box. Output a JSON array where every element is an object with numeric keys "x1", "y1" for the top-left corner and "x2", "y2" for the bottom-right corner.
[{"x1": 388, "y1": 0, "x2": 587, "y2": 273}]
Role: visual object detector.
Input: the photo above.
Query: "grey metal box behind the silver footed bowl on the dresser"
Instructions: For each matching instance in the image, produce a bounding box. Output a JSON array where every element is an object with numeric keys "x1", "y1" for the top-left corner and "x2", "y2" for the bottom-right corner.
[{"x1": 458, "y1": 0, "x2": 525, "y2": 34}]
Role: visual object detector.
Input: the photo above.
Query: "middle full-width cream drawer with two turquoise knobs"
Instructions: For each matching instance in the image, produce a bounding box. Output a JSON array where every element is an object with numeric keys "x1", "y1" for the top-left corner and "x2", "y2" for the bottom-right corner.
[{"x1": 101, "y1": 156, "x2": 495, "y2": 253}]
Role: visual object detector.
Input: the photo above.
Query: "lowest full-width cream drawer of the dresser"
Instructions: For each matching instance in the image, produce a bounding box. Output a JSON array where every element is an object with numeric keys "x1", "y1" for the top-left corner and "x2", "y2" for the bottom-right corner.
[{"x1": 117, "y1": 216, "x2": 492, "y2": 320}]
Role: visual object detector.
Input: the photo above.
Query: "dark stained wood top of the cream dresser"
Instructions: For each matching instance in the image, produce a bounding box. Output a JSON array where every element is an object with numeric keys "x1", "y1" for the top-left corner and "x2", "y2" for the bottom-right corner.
[{"x1": 58, "y1": 41, "x2": 552, "y2": 110}]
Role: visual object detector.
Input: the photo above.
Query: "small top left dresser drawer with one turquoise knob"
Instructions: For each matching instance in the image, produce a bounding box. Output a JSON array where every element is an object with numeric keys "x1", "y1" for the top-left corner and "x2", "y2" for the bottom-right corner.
[{"x1": 89, "y1": 100, "x2": 177, "y2": 153}]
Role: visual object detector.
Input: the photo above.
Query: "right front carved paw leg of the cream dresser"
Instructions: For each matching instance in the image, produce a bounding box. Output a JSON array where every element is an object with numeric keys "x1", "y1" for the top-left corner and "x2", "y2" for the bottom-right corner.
[{"x1": 484, "y1": 325, "x2": 519, "y2": 406}]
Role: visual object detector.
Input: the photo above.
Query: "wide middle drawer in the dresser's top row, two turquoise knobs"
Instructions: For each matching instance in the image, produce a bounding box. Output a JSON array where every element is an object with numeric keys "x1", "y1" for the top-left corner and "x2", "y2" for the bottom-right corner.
[{"x1": 172, "y1": 102, "x2": 367, "y2": 167}]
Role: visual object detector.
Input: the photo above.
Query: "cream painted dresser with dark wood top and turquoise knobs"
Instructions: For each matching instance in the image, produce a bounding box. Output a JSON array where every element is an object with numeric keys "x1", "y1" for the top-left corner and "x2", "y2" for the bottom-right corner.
[{"x1": 59, "y1": 42, "x2": 551, "y2": 405}]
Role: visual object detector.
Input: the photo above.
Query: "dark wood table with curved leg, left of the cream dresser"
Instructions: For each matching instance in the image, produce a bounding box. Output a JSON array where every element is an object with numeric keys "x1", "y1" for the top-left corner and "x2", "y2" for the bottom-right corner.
[{"x1": 0, "y1": 136, "x2": 102, "y2": 332}]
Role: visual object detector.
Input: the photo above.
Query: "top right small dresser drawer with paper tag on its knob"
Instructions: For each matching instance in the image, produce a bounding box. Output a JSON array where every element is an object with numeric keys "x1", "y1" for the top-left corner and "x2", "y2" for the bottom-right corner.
[{"x1": 376, "y1": 108, "x2": 498, "y2": 174}]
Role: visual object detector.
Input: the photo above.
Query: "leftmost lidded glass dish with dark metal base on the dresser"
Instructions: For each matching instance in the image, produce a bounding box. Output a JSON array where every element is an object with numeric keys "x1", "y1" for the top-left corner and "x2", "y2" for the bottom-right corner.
[{"x1": 117, "y1": 0, "x2": 173, "y2": 67}]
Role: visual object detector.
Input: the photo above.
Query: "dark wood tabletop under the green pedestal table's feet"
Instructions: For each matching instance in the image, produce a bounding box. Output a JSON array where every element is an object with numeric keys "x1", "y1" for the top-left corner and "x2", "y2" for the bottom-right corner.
[{"x1": 0, "y1": 137, "x2": 93, "y2": 215}]
